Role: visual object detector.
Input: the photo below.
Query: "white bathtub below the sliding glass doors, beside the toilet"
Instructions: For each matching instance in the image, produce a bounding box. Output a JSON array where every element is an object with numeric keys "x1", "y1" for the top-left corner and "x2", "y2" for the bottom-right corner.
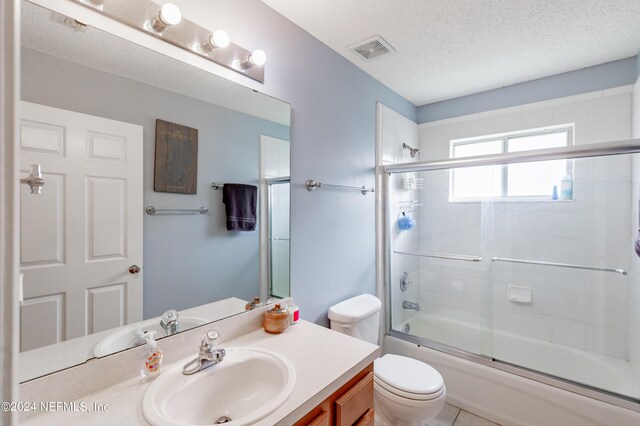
[{"x1": 383, "y1": 321, "x2": 640, "y2": 426}]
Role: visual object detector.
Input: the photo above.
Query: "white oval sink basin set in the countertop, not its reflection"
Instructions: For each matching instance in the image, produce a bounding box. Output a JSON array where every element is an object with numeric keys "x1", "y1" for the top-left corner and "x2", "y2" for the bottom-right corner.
[{"x1": 142, "y1": 346, "x2": 296, "y2": 426}]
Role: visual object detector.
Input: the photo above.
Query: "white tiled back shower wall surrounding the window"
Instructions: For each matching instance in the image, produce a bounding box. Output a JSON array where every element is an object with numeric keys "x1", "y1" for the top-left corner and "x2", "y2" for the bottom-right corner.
[{"x1": 413, "y1": 86, "x2": 637, "y2": 359}]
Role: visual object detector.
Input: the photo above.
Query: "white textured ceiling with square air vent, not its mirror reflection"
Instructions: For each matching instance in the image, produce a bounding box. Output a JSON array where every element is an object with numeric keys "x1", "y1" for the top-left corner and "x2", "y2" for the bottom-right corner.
[{"x1": 263, "y1": 0, "x2": 640, "y2": 106}]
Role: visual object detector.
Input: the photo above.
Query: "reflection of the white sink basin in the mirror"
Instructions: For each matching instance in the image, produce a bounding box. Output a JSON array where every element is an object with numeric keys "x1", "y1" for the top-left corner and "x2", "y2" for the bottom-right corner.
[{"x1": 93, "y1": 317, "x2": 208, "y2": 357}]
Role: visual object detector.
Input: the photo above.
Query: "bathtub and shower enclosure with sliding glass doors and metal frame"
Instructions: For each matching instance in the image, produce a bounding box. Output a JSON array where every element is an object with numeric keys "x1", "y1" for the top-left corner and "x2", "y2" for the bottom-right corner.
[{"x1": 382, "y1": 140, "x2": 640, "y2": 425}]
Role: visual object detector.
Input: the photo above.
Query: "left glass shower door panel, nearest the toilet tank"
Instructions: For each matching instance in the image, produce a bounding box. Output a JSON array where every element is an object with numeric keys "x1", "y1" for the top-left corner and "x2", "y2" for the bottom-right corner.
[{"x1": 387, "y1": 170, "x2": 493, "y2": 356}]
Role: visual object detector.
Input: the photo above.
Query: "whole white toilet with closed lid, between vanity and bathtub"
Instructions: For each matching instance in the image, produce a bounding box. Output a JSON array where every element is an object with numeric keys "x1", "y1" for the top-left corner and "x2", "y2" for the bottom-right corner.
[{"x1": 329, "y1": 294, "x2": 447, "y2": 426}]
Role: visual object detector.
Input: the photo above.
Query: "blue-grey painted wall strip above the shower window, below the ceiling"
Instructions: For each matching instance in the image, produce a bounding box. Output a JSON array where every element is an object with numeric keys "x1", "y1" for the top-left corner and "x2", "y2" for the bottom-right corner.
[{"x1": 417, "y1": 56, "x2": 640, "y2": 123}]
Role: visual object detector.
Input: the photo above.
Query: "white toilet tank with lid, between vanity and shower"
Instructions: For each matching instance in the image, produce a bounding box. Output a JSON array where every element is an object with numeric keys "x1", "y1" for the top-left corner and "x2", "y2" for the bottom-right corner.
[{"x1": 329, "y1": 294, "x2": 382, "y2": 345}]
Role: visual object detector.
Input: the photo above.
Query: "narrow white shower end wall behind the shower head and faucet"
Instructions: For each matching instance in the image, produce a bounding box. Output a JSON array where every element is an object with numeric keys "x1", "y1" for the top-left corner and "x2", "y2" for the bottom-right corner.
[{"x1": 378, "y1": 104, "x2": 421, "y2": 325}]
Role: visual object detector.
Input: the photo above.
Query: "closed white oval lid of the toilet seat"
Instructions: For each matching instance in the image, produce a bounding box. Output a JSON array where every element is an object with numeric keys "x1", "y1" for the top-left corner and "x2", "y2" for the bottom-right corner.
[{"x1": 373, "y1": 354, "x2": 444, "y2": 395}]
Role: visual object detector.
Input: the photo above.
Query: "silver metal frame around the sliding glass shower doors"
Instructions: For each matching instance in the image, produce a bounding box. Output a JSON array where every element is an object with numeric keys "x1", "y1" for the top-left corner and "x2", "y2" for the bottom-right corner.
[{"x1": 382, "y1": 139, "x2": 640, "y2": 412}]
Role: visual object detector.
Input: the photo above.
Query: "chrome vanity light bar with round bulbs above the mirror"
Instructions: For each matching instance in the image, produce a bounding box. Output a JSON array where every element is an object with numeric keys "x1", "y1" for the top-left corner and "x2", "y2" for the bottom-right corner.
[{"x1": 73, "y1": 0, "x2": 266, "y2": 83}]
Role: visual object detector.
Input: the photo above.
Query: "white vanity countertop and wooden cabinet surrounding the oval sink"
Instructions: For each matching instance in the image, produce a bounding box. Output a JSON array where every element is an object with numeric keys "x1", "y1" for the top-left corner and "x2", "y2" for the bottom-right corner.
[{"x1": 20, "y1": 307, "x2": 379, "y2": 426}]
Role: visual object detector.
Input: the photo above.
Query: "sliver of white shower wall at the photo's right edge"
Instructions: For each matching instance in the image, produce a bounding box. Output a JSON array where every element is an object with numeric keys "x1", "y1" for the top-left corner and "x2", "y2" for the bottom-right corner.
[{"x1": 629, "y1": 78, "x2": 640, "y2": 380}]
